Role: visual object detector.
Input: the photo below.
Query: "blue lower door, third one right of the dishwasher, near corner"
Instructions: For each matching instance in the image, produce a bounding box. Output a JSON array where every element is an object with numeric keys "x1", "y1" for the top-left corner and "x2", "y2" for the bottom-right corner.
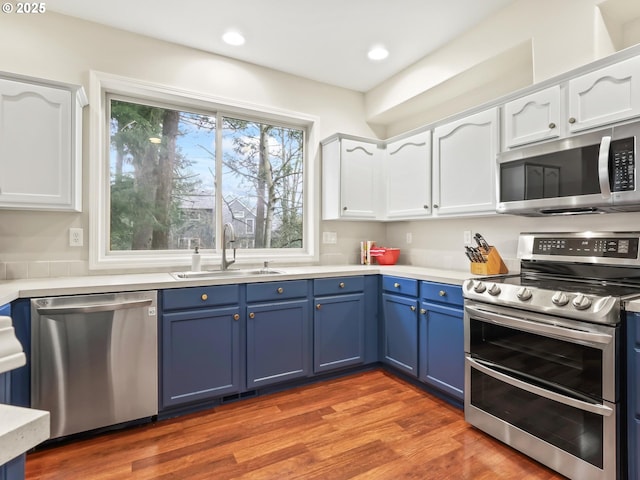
[{"x1": 313, "y1": 293, "x2": 365, "y2": 373}]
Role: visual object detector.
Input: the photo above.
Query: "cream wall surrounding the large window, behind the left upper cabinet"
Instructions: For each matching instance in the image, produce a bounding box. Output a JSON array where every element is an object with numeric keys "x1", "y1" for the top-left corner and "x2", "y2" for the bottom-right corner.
[{"x1": 0, "y1": 12, "x2": 384, "y2": 280}]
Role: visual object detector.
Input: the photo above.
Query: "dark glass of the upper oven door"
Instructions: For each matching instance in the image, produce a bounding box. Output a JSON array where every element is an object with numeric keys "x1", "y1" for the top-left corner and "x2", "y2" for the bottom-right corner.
[{"x1": 469, "y1": 318, "x2": 604, "y2": 402}]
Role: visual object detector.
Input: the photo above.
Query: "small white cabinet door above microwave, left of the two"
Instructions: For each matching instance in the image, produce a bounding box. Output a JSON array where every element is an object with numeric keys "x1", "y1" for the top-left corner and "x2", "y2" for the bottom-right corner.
[{"x1": 504, "y1": 85, "x2": 564, "y2": 148}]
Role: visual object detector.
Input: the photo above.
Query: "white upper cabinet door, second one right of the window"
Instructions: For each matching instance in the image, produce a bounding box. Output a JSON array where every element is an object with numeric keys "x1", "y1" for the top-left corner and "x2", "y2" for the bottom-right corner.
[{"x1": 385, "y1": 130, "x2": 431, "y2": 220}]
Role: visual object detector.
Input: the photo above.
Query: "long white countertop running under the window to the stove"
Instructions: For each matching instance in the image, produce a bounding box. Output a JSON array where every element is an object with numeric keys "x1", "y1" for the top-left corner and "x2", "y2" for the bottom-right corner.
[{"x1": 0, "y1": 265, "x2": 476, "y2": 305}]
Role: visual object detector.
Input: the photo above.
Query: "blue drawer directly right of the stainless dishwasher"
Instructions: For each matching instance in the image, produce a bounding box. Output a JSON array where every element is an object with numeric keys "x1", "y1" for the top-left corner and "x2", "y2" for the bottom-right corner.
[{"x1": 162, "y1": 285, "x2": 240, "y2": 311}]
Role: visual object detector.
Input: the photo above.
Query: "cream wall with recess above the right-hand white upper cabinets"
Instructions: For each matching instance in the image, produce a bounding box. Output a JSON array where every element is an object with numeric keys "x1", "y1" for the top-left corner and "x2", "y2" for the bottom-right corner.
[{"x1": 365, "y1": 0, "x2": 628, "y2": 136}]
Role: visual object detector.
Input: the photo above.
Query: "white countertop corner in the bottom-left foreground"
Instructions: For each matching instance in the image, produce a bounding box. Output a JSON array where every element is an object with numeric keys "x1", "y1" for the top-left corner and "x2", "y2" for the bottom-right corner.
[{"x1": 0, "y1": 404, "x2": 50, "y2": 465}]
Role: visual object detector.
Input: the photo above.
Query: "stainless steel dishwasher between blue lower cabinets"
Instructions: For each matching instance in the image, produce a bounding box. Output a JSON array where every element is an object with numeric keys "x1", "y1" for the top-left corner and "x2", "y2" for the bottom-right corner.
[{"x1": 31, "y1": 291, "x2": 158, "y2": 438}]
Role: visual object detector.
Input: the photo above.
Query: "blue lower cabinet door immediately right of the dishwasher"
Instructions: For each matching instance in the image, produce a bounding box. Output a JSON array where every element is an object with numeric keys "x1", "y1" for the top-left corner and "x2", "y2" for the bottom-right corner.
[{"x1": 161, "y1": 306, "x2": 241, "y2": 407}]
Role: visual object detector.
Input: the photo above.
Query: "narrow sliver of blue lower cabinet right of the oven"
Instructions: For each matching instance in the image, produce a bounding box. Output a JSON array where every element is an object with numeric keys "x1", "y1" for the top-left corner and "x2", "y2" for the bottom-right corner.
[{"x1": 623, "y1": 313, "x2": 640, "y2": 480}]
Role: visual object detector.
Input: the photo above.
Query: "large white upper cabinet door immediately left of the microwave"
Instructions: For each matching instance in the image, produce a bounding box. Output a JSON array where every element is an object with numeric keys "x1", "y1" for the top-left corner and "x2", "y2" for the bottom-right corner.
[{"x1": 433, "y1": 108, "x2": 498, "y2": 217}]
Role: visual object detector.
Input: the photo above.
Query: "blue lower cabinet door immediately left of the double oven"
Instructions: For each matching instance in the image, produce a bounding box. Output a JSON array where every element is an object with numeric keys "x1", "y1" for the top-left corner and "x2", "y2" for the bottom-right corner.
[{"x1": 418, "y1": 302, "x2": 464, "y2": 401}]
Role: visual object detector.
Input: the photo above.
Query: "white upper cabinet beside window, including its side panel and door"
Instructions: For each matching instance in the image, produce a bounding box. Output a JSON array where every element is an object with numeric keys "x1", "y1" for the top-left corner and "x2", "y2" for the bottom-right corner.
[{"x1": 322, "y1": 136, "x2": 384, "y2": 220}]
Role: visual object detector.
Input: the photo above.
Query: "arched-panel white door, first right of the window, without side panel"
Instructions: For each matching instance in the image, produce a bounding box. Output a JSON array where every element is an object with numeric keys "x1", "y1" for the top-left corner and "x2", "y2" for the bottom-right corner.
[{"x1": 340, "y1": 139, "x2": 382, "y2": 219}]
